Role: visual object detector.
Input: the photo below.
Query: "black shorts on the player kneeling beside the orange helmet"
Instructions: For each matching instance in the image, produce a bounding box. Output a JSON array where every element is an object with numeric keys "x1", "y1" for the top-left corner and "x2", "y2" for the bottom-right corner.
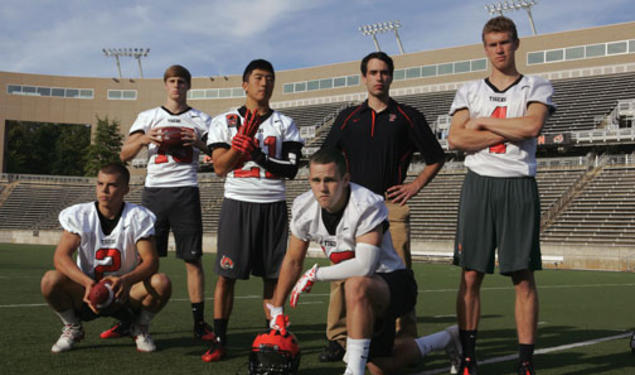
[{"x1": 369, "y1": 269, "x2": 417, "y2": 358}]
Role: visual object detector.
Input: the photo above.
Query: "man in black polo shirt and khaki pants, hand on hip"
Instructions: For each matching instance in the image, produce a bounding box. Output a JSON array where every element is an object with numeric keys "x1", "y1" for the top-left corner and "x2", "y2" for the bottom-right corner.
[{"x1": 320, "y1": 52, "x2": 445, "y2": 362}]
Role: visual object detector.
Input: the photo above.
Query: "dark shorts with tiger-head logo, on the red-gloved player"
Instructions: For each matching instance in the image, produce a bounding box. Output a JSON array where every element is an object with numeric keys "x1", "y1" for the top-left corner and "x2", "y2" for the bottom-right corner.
[{"x1": 216, "y1": 198, "x2": 289, "y2": 280}]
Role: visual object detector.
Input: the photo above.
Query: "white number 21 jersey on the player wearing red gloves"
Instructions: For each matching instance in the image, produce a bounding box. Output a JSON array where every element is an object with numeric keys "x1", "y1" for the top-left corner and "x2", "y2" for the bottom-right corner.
[{"x1": 207, "y1": 109, "x2": 304, "y2": 203}]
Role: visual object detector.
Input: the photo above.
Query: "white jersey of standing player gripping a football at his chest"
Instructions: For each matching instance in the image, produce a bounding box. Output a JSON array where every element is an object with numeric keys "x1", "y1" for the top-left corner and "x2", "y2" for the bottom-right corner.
[{"x1": 129, "y1": 107, "x2": 212, "y2": 187}]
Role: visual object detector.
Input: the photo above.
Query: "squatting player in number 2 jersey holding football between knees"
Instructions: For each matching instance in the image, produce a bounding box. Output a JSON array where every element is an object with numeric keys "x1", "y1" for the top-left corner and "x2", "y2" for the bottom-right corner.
[{"x1": 41, "y1": 164, "x2": 171, "y2": 353}]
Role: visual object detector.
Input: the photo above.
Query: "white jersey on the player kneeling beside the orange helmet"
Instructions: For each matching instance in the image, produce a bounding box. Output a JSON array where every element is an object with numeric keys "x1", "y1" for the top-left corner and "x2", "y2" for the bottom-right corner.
[{"x1": 290, "y1": 182, "x2": 405, "y2": 273}]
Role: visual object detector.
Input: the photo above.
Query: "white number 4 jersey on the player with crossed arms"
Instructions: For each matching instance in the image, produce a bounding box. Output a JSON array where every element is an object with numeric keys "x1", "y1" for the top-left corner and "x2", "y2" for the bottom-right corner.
[{"x1": 450, "y1": 76, "x2": 555, "y2": 177}]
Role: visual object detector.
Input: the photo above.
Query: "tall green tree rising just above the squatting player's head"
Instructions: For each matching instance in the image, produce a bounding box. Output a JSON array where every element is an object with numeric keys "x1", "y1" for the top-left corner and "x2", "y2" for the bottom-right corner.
[{"x1": 84, "y1": 116, "x2": 123, "y2": 176}]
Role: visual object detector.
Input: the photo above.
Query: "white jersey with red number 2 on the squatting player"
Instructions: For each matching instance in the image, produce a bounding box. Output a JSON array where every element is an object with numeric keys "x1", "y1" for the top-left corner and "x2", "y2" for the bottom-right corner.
[{"x1": 59, "y1": 202, "x2": 155, "y2": 280}]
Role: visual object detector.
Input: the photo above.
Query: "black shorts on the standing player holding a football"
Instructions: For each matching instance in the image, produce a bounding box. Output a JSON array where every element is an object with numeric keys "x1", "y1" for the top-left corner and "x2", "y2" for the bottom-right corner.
[{"x1": 142, "y1": 186, "x2": 203, "y2": 262}]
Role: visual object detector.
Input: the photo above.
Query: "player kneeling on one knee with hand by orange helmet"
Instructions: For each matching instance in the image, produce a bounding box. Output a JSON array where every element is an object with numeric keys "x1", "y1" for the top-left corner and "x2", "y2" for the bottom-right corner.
[{"x1": 270, "y1": 148, "x2": 460, "y2": 375}]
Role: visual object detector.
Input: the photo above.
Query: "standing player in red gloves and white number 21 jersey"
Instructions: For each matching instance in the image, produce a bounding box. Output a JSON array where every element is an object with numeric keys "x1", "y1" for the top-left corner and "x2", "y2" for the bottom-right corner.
[{"x1": 202, "y1": 60, "x2": 304, "y2": 362}]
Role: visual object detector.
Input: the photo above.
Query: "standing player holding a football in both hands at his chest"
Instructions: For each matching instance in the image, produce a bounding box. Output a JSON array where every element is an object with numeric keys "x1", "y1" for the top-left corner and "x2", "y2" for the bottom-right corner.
[{"x1": 119, "y1": 65, "x2": 214, "y2": 340}]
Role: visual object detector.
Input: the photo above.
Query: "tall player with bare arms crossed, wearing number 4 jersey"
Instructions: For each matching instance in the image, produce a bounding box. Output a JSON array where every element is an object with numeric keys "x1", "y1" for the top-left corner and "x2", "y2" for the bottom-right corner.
[{"x1": 448, "y1": 16, "x2": 555, "y2": 375}]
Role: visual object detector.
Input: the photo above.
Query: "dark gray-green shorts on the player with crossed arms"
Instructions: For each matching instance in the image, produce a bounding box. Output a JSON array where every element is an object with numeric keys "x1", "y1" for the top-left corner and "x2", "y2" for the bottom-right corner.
[{"x1": 454, "y1": 171, "x2": 542, "y2": 275}]
